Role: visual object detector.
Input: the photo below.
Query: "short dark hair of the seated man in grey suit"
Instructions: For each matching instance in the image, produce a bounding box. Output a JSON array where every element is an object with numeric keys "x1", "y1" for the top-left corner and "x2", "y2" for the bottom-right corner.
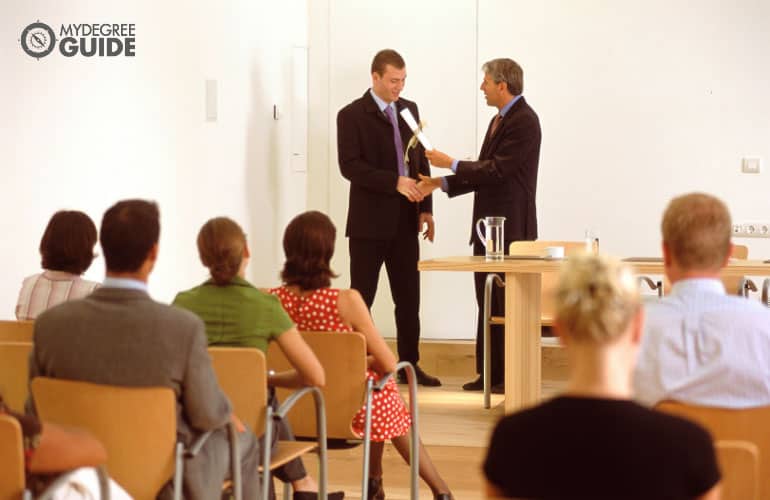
[{"x1": 99, "y1": 200, "x2": 160, "y2": 272}]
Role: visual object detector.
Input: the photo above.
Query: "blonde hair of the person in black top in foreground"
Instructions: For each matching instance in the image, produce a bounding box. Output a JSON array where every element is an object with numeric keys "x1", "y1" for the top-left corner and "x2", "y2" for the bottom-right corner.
[{"x1": 556, "y1": 254, "x2": 641, "y2": 344}]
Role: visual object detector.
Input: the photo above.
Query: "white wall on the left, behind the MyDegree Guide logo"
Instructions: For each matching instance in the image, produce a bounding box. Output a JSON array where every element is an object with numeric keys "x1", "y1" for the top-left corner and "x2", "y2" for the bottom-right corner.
[{"x1": 0, "y1": 0, "x2": 307, "y2": 318}]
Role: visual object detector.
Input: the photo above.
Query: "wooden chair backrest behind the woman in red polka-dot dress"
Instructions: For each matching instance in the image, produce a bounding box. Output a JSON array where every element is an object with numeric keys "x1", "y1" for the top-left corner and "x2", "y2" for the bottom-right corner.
[{"x1": 267, "y1": 332, "x2": 366, "y2": 439}]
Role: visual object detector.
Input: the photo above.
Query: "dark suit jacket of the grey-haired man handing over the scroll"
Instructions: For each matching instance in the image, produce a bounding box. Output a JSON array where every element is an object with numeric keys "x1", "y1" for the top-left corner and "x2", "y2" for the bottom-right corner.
[{"x1": 447, "y1": 97, "x2": 540, "y2": 244}]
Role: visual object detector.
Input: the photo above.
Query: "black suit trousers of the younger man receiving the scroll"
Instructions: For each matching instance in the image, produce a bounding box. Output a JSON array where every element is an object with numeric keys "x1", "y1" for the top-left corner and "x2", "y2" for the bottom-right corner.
[{"x1": 348, "y1": 197, "x2": 420, "y2": 364}]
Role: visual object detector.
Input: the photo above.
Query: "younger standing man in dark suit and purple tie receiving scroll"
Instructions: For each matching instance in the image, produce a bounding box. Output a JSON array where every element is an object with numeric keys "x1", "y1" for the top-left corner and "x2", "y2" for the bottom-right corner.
[{"x1": 337, "y1": 49, "x2": 441, "y2": 386}]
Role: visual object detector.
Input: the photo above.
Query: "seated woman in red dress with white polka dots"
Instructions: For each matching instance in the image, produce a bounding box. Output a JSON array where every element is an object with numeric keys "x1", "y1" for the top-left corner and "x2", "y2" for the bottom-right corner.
[{"x1": 271, "y1": 212, "x2": 452, "y2": 500}]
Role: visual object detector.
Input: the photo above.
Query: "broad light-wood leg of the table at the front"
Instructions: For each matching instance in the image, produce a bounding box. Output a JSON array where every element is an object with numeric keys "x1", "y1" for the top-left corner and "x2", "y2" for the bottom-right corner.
[{"x1": 505, "y1": 273, "x2": 541, "y2": 413}]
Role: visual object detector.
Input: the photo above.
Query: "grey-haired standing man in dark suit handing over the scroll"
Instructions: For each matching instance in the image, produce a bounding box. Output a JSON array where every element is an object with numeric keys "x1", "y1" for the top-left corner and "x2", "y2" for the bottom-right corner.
[{"x1": 418, "y1": 59, "x2": 540, "y2": 393}]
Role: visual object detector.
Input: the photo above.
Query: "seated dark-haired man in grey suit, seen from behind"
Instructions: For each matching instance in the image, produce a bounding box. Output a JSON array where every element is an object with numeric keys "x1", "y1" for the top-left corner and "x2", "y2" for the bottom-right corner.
[{"x1": 30, "y1": 200, "x2": 259, "y2": 500}]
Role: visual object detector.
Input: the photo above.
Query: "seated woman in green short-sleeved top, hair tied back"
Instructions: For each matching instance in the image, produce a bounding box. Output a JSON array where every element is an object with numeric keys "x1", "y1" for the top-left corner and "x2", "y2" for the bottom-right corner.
[{"x1": 174, "y1": 217, "x2": 343, "y2": 500}]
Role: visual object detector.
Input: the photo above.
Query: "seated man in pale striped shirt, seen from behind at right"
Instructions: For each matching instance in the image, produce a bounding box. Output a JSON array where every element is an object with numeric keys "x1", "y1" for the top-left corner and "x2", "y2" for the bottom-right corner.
[{"x1": 634, "y1": 193, "x2": 770, "y2": 408}]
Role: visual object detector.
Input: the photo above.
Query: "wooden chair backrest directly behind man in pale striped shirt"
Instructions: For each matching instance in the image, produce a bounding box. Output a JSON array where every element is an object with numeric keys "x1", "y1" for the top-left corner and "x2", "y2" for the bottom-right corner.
[{"x1": 656, "y1": 401, "x2": 770, "y2": 500}]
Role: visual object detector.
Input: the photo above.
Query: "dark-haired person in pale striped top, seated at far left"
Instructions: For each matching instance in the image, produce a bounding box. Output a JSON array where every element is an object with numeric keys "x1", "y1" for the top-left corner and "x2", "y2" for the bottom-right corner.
[{"x1": 16, "y1": 210, "x2": 99, "y2": 320}]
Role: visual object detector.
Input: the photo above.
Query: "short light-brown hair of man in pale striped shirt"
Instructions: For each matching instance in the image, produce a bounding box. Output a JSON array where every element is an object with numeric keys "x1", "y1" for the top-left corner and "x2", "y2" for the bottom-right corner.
[{"x1": 660, "y1": 193, "x2": 732, "y2": 270}]
